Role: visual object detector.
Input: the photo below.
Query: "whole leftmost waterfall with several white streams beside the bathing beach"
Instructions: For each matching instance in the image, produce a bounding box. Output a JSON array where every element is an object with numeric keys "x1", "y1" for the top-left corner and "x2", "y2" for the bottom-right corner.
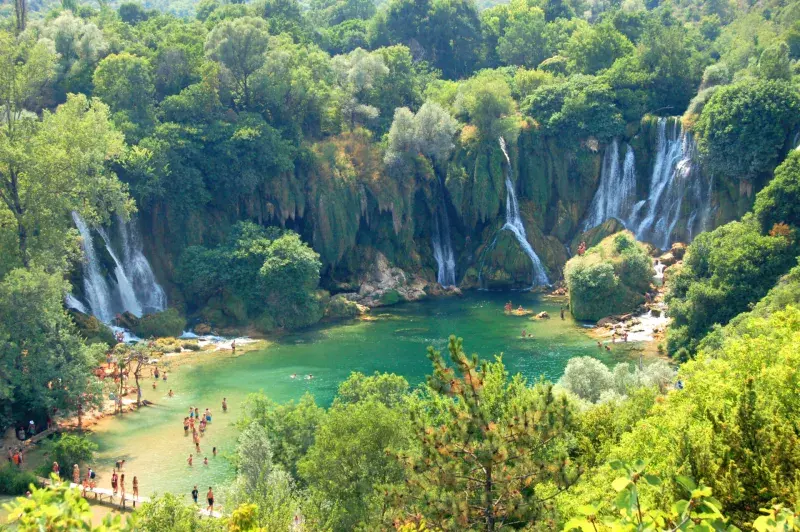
[{"x1": 67, "y1": 212, "x2": 166, "y2": 323}]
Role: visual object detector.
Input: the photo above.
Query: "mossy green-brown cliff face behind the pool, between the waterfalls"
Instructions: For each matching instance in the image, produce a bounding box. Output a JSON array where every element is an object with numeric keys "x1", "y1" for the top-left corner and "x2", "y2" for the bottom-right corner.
[{"x1": 142, "y1": 117, "x2": 754, "y2": 300}]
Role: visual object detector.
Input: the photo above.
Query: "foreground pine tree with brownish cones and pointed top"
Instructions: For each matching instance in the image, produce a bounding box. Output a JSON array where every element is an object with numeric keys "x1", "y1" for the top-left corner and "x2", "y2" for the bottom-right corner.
[{"x1": 400, "y1": 336, "x2": 576, "y2": 531}]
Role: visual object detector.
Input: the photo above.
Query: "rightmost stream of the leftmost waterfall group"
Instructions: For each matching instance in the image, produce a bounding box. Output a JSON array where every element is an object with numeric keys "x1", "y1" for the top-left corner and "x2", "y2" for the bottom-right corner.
[{"x1": 117, "y1": 219, "x2": 167, "y2": 314}]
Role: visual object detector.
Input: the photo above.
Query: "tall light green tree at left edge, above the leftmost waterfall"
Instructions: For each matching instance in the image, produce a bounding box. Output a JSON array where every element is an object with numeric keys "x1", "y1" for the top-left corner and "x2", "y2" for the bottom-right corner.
[{"x1": 0, "y1": 85, "x2": 133, "y2": 268}]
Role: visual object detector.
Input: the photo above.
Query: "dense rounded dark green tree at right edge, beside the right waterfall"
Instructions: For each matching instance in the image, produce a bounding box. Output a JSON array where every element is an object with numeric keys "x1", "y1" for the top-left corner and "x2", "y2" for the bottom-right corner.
[{"x1": 695, "y1": 80, "x2": 800, "y2": 180}]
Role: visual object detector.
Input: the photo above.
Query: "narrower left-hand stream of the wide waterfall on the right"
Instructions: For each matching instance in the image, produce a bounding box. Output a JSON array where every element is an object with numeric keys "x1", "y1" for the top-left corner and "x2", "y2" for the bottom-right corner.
[{"x1": 583, "y1": 139, "x2": 636, "y2": 231}]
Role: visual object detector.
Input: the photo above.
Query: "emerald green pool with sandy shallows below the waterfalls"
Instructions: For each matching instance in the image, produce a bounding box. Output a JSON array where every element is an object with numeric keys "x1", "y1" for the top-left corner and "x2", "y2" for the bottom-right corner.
[{"x1": 87, "y1": 292, "x2": 623, "y2": 499}]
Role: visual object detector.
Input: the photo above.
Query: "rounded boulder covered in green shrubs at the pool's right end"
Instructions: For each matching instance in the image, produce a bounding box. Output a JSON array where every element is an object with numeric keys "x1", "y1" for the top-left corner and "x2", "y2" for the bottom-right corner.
[{"x1": 564, "y1": 231, "x2": 653, "y2": 320}]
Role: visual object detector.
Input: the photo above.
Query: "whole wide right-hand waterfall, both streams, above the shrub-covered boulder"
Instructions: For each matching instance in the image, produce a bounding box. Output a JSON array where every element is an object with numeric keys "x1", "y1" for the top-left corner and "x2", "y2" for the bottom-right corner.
[{"x1": 584, "y1": 118, "x2": 713, "y2": 249}]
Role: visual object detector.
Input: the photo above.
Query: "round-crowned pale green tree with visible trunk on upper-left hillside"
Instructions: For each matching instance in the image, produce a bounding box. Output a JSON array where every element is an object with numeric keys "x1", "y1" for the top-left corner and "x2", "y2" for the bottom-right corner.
[{"x1": 206, "y1": 17, "x2": 269, "y2": 109}]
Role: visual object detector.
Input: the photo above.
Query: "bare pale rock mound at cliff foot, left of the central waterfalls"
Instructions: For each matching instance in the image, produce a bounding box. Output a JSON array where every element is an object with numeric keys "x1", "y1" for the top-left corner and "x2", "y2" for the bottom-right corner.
[{"x1": 345, "y1": 252, "x2": 428, "y2": 308}]
